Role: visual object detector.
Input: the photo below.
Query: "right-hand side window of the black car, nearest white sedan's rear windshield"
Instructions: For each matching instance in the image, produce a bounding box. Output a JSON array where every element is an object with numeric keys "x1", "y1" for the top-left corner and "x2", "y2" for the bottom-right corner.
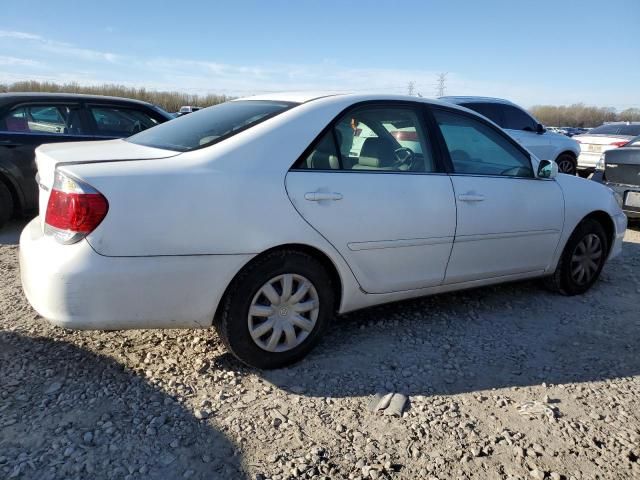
[{"x1": 89, "y1": 106, "x2": 160, "y2": 137}]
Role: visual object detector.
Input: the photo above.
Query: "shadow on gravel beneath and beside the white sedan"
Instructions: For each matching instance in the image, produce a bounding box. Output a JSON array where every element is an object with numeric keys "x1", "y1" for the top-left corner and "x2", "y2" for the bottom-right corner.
[{"x1": 255, "y1": 243, "x2": 640, "y2": 397}]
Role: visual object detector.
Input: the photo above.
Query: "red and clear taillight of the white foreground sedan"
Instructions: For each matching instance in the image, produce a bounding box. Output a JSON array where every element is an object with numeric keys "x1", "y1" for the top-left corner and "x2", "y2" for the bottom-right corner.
[{"x1": 44, "y1": 172, "x2": 109, "y2": 243}]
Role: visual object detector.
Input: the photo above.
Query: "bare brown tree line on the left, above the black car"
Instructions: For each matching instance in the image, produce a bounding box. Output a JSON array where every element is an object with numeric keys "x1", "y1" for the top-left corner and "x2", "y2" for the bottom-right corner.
[{"x1": 0, "y1": 81, "x2": 231, "y2": 112}]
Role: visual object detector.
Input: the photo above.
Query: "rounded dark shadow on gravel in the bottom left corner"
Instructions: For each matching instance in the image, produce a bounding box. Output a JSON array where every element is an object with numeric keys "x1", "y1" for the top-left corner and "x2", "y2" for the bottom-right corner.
[{"x1": 0, "y1": 331, "x2": 245, "y2": 480}]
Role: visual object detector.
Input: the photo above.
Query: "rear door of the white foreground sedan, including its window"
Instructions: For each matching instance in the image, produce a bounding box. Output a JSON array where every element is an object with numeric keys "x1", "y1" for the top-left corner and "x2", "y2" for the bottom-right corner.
[{"x1": 286, "y1": 103, "x2": 456, "y2": 293}]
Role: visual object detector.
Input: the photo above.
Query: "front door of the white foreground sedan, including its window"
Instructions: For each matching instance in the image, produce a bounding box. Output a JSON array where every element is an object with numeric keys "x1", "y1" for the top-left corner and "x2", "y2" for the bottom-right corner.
[{"x1": 433, "y1": 108, "x2": 564, "y2": 284}]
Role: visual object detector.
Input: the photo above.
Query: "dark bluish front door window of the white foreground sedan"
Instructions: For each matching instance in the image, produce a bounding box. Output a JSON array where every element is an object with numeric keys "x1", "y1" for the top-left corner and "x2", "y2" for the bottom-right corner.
[{"x1": 434, "y1": 110, "x2": 533, "y2": 177}]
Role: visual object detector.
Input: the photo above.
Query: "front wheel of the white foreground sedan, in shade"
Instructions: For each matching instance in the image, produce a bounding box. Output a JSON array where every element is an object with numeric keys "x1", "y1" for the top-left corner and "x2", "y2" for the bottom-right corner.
[{"x1": 547, "y1": 218, "x2": 609, "y2": 295}]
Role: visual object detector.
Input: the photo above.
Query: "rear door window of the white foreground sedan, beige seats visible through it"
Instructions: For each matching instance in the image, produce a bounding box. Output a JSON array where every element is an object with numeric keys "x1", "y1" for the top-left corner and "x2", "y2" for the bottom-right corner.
[{"x1": 295, "y1": 106, "x2": 435, "y2": 172}]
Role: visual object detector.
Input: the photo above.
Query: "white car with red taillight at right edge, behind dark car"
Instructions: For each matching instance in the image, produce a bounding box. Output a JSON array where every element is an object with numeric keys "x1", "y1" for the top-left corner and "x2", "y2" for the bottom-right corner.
[{"x1": 573, "y1": 122, "x2": 640, "y2": 175}]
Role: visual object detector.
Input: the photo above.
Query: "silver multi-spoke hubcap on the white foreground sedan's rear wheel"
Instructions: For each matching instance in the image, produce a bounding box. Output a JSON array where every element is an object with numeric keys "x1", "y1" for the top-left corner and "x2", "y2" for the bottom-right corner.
[{"x1": 248, "y1": 273, "x2": 320, "y2": 352}]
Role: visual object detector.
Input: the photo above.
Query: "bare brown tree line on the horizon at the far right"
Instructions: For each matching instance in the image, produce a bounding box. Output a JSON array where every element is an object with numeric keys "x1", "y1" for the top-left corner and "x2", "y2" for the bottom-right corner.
[{"x1": 529, "y1": 103, "x2": 640, "y2": 127}]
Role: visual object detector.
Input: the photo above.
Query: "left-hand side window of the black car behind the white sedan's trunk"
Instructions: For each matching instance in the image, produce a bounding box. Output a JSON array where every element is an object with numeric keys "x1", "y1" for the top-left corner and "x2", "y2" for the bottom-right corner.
[{"x1": 0, "y1": 105, "x2": 87, "y2": 135}]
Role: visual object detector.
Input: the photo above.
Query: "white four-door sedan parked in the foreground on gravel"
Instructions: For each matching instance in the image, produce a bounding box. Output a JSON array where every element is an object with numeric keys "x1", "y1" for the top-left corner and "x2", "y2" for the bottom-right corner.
[{"x1": 20, "y1": 94, "x2": 626, "y2": 368}]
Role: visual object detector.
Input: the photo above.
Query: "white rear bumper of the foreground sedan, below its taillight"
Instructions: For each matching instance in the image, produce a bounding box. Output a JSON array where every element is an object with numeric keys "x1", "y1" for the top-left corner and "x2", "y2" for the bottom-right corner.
[{"x1": 20, "y1": 218, "x2": 251, "y2": 330}]
